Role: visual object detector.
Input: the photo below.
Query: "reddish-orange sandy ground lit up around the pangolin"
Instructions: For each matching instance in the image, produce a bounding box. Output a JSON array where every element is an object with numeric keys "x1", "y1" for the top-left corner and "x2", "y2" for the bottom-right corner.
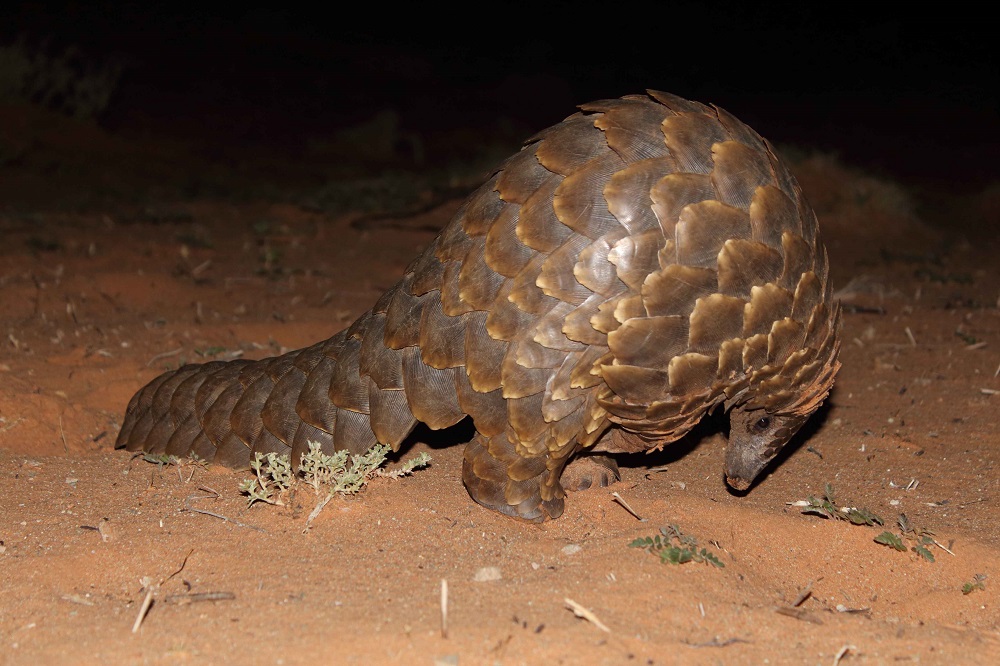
[{"x1": 0, "y1": 106, "x2": 1000, "y2": 664}]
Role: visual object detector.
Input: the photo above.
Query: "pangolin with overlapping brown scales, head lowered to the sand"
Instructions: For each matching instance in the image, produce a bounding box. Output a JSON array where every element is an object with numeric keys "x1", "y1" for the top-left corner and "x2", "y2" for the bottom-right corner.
[{"x1": 116, "y1": 91, "x2": 840, "y2": 522}]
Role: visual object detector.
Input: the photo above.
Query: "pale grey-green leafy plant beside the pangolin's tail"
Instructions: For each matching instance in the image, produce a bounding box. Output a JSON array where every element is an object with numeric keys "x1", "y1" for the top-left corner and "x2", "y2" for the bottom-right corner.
[{"x1": 240, "y1": 442, "x2": 431, "y2": 506}]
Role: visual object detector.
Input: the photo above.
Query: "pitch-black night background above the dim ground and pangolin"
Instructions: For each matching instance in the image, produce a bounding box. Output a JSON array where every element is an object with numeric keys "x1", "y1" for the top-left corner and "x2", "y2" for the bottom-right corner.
[{"x1": 0, "y1": 2, "x2": 1000, "y2": 200}]
